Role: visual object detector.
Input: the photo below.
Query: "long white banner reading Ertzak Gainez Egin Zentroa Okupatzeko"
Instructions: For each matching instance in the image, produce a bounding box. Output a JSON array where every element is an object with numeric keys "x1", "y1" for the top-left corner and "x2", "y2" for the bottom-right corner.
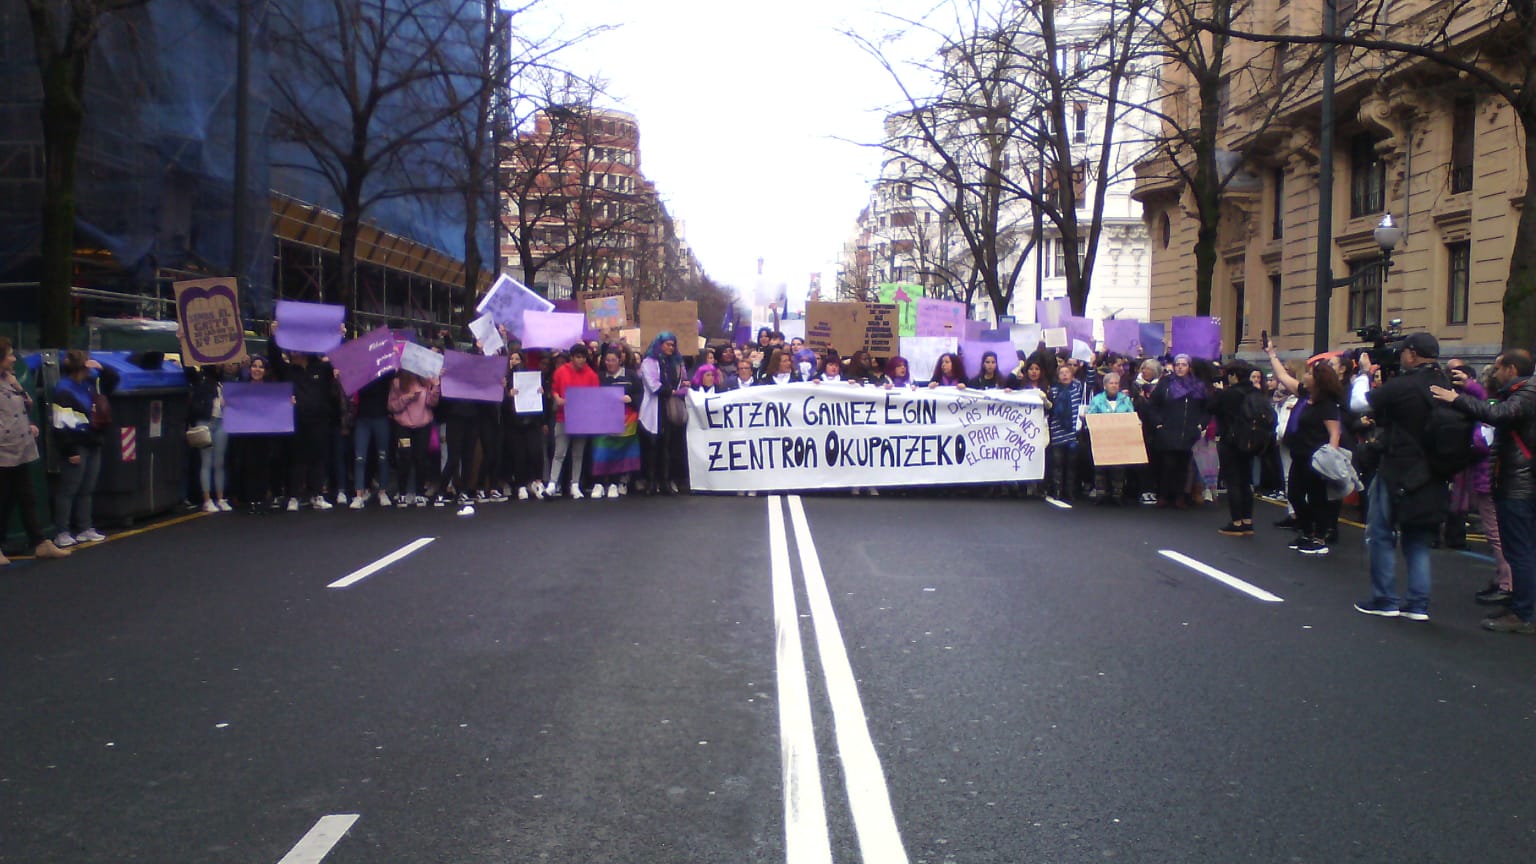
[{"x1": 688, "y1": 384, "x2": 1051, "y2": 492}]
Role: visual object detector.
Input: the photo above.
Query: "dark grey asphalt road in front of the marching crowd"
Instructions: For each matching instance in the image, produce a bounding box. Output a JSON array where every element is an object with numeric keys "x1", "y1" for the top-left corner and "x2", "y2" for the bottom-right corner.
[{"x1": 0, "y1": 495, "x2": 1536, "y2": 864}]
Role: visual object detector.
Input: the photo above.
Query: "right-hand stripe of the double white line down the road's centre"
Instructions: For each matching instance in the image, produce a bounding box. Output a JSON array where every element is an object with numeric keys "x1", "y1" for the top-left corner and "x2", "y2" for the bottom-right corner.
[{"x1": 790, "y1": 495, "x2": 906, "y2": 864}]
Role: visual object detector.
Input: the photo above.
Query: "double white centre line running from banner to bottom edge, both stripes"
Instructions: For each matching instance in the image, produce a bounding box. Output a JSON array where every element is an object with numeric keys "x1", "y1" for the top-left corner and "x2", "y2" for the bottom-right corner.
[{"x1": 768, "y1": 495, "x2": 906, "y2": 864}]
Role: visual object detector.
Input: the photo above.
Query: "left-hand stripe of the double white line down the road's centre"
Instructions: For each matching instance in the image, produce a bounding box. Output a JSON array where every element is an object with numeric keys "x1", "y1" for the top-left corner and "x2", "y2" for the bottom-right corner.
[{"x1": 768, "y1": 495, "x2": 833, "y2": 864}]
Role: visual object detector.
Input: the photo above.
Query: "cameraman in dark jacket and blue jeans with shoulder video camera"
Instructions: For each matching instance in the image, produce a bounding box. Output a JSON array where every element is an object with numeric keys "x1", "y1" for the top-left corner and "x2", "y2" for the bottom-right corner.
[{"x1": 1350, "y1": 334, "x2": 1450, "y2": 621}]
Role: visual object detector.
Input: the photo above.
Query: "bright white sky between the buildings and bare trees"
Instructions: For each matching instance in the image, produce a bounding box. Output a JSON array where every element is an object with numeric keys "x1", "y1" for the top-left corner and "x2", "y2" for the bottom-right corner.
[{"x1": 519, "y1": 0, "x2": 938, "y2": 304}]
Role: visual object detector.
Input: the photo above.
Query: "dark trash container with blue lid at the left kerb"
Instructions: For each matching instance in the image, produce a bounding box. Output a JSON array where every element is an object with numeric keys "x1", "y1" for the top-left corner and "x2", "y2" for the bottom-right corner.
[{"x1": 91, "y1": 351, "x2": 189, "y2": 527}]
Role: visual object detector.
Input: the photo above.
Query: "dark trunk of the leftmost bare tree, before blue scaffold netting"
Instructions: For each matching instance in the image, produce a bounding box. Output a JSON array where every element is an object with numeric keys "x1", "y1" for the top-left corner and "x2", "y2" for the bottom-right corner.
[{"x1": 26, "y1": 0, "x2": 149, "y2": 347}]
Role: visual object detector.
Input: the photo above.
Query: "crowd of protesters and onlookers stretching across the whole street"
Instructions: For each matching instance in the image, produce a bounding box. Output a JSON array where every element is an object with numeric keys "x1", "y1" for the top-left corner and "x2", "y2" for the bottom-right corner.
[{"x1": 0, "y1": 322, "x2": 1536, "y2": 632}]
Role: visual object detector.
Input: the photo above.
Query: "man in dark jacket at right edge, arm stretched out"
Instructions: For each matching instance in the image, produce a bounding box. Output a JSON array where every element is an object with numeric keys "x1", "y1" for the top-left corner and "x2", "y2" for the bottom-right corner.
[{"x1": 1430, "y1": 351, "x2": 1536, "y2": 633}]
